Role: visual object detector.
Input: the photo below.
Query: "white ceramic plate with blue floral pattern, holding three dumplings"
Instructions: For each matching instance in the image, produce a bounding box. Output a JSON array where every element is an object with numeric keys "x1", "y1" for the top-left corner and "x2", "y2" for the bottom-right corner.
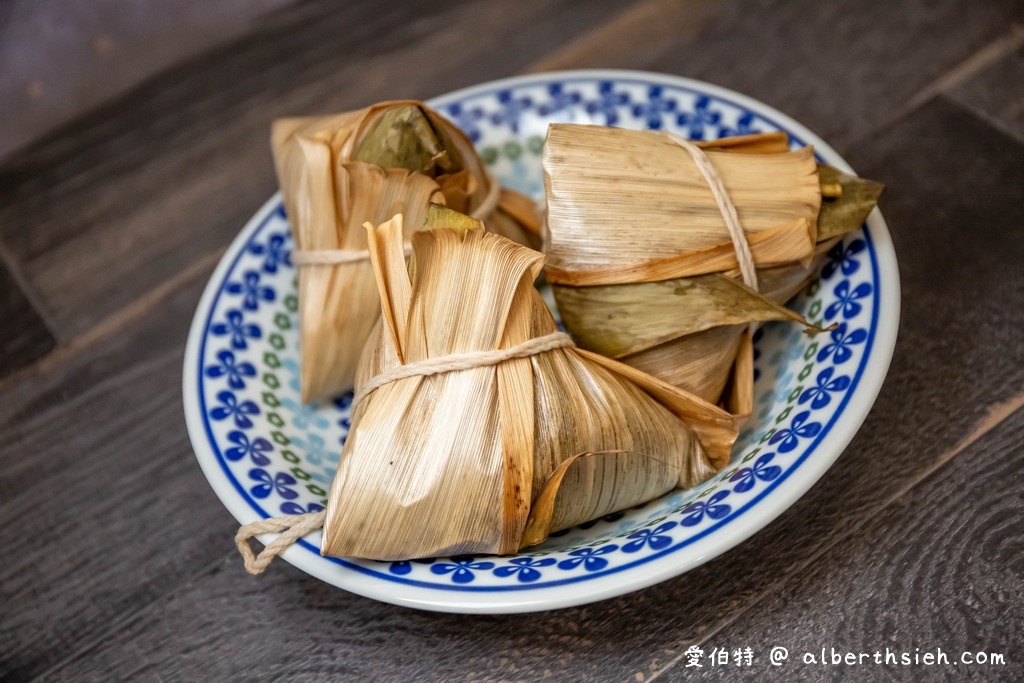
[{"x1": 183, "y1": 71, "x2": 899, "y2": 612}]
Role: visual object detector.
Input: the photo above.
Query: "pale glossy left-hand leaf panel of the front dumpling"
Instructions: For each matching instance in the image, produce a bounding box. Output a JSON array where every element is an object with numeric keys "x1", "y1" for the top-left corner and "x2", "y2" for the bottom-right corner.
[{"x1": 325, "y1": 224, "x2": 542, "y2": 559}]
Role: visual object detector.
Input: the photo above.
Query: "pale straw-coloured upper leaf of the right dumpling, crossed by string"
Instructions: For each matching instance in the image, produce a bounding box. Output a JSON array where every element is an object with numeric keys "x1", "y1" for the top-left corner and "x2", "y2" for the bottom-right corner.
[{"x1": 544, "y1": 124, "x2": 821, "y2": 284}]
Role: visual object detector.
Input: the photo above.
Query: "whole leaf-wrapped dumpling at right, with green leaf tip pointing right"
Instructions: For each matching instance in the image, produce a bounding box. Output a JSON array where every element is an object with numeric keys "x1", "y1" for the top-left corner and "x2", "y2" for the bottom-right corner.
[{"x1": 544, "y1": 124, "x2": 882, "y2": 416}]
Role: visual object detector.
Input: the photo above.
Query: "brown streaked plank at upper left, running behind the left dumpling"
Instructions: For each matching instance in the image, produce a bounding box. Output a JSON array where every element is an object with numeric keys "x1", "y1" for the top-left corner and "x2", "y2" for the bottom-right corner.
[{"x1": 0, "y1": 0, "x2": 629, "y2": 341}]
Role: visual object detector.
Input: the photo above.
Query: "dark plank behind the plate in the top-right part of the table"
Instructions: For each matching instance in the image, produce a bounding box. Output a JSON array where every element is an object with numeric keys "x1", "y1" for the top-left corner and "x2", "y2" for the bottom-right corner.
[{"x1": 541, "y1": 0, "x2": 1024, "y2": 148}]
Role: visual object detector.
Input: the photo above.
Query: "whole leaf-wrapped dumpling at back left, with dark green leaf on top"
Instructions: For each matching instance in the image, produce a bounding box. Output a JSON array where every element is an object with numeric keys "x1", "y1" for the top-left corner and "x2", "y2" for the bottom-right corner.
[{"x1": 271, "y1": 100, "x2": 539, "y2": 401}]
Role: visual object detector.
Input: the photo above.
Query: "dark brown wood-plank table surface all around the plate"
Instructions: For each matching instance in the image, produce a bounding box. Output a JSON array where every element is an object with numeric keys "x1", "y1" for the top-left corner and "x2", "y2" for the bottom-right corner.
[{"x1": 0, "y1": 0, "x2": 1024, "y2": 681}]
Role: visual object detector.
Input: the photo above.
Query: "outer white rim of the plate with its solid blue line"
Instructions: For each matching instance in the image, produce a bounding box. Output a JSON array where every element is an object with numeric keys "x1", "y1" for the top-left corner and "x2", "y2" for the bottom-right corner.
[{"x1": 184, "y1": 71, "x2": 899, "y2": 612}]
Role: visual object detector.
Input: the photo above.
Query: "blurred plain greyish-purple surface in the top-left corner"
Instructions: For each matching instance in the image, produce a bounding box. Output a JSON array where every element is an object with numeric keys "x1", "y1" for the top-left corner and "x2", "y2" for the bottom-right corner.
[{"x1": 0, "y1": 0, "x2": 294, "y2": 159}]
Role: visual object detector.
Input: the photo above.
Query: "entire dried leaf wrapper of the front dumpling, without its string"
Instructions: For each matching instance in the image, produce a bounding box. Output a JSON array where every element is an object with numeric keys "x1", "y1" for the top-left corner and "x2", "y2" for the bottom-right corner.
[{"x1": 324, "y1": 219, "x2": 735, "y2": 559}]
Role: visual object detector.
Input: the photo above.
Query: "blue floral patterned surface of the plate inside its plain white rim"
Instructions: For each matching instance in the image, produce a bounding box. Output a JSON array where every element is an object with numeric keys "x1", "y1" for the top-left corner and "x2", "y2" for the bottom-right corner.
[{"x1": 185, "y1": 75, "x2": 880, "y2": 592}]
